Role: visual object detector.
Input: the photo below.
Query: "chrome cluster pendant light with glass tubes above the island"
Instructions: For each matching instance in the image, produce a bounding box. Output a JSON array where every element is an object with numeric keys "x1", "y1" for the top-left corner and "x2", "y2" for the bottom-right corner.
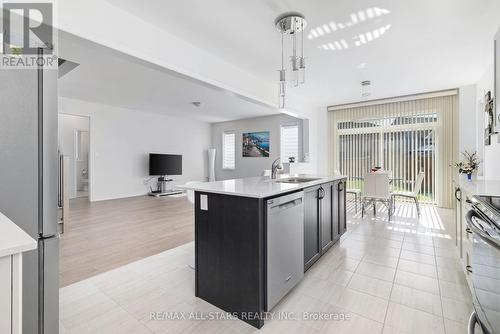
[{"x1": 274, "y1": 13, "x2": 306, "y2": 109}]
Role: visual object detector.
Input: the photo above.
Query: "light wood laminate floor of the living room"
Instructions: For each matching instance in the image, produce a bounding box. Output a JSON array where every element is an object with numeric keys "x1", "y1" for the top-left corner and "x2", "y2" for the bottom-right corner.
[{"x1": 59, "y1": 196, "x2": 194, "y2": 287}]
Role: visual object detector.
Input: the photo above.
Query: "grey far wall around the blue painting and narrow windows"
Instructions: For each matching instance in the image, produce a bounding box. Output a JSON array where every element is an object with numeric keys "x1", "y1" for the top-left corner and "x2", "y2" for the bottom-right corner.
[{"x1": 212, "y1": 115, "x2": 312, "y2": 180}]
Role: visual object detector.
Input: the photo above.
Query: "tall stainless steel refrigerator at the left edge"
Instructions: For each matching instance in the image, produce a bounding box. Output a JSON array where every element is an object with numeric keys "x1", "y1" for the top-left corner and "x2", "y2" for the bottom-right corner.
[{"x1": 0, "y1": 49, "x2": 59, "y2": 334}]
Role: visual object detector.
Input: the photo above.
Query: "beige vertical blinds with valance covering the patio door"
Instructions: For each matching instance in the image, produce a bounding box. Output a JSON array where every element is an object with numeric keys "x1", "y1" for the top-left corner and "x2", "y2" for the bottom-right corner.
[{"x1": 329, "y1": 93, "x2": 457, "y2": 207}]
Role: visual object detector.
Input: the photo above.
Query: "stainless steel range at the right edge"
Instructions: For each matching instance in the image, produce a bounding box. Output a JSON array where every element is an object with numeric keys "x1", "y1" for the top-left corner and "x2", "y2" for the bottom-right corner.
[{"x1": 466, "y1": 196, "x2": 500, "y2": 334}]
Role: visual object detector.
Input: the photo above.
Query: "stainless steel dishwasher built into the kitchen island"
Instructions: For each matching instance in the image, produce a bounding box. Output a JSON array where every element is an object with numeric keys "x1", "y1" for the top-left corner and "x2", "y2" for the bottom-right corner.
[{"x1": 266, "y1": 191, "x2": 304, "y2": 311}]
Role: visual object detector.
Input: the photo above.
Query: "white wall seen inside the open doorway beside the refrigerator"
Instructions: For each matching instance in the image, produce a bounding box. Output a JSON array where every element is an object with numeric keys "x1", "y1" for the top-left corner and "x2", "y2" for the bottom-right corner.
[{"x1": 58, "y1": 114, "x2": 89, "y2": 198}]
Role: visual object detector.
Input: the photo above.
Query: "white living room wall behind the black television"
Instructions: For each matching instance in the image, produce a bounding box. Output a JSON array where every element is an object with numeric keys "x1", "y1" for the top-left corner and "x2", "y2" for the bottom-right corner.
[{"x1": 59, "y1": 98, "x2": 211, "y2": 201}]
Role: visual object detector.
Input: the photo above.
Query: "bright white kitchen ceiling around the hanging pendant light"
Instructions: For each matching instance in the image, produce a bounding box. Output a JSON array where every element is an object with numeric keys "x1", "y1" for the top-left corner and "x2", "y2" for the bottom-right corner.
[{"x1": 108, "y1": 0, "x2": 500, "y2": 106}]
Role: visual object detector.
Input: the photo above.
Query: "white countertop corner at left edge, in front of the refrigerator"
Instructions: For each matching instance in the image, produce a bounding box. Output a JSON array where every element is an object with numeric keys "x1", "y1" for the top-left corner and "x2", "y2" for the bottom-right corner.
[{"x1": 0, "y1": 212, "x2": 37, "y2": 257}]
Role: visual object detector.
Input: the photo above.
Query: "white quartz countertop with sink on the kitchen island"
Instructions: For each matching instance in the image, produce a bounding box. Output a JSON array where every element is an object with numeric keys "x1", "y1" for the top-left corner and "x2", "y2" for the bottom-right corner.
[{"x1": 178, "y1": 175, "x2": 345, "y2": 198}]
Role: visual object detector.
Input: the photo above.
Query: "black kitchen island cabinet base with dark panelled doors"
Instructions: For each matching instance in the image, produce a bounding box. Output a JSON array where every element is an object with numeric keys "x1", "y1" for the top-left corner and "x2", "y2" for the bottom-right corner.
[{"x1": 184, "y1": 177, "x2": 346, "y2": 328}]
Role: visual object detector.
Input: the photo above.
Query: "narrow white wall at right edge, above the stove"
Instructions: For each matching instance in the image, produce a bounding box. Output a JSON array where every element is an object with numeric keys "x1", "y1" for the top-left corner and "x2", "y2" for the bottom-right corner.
[{"x1": 477, "y1": 64, "x2": 500, "y2": 180}]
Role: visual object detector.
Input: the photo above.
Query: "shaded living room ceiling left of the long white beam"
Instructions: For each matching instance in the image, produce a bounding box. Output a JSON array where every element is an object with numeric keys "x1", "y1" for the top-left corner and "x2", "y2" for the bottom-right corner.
[{"x1": 59, "y1": 31, "x2": 279, "y2": 122}]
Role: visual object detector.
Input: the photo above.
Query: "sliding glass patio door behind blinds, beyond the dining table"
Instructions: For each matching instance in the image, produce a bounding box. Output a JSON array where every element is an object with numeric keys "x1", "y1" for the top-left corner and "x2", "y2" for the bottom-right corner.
[{"x1": 337, "y1": 113, "x2": 438, "y2": 203}]
